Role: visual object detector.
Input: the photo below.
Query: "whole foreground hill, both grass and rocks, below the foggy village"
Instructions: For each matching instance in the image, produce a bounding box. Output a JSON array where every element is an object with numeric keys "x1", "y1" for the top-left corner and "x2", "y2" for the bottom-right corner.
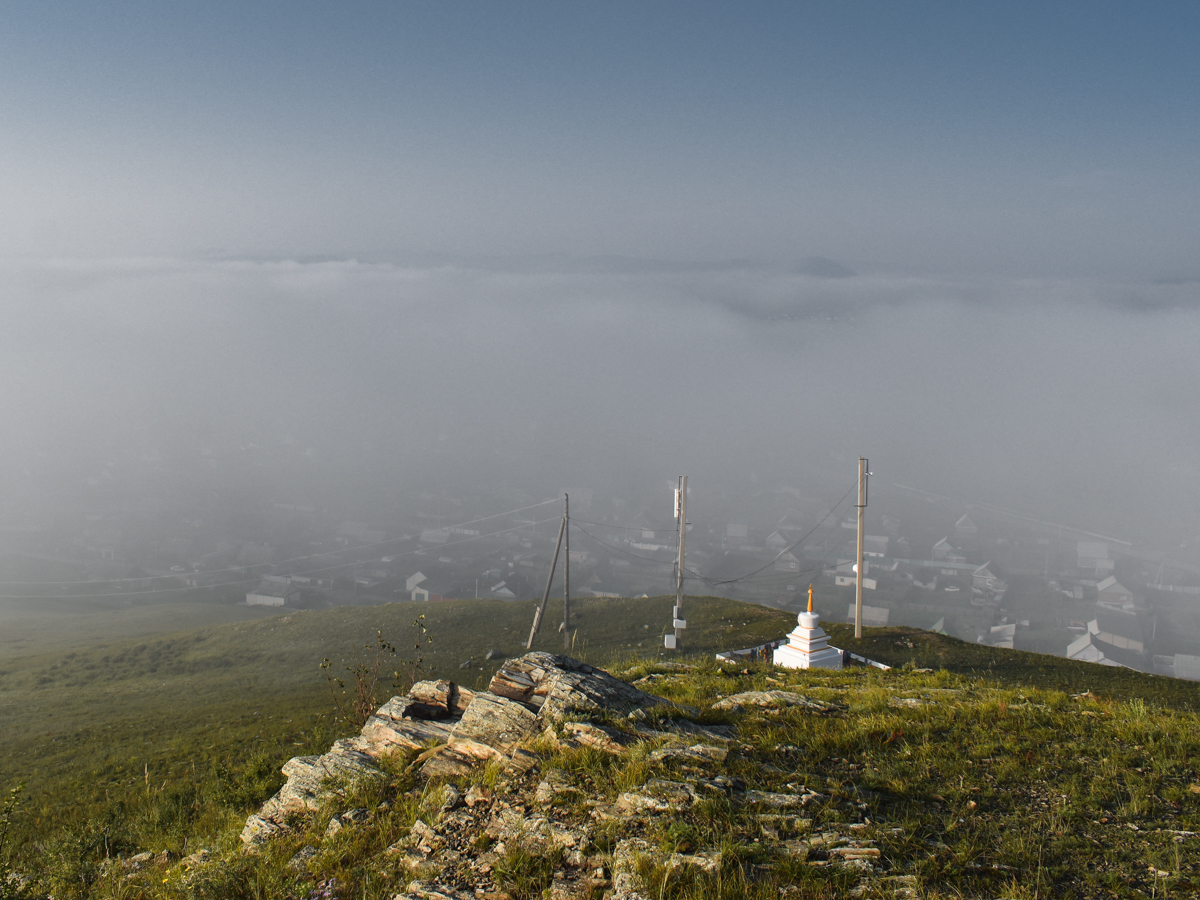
[{"x1": 0, "y1": 598, "x2": 1200, "y2": 900}]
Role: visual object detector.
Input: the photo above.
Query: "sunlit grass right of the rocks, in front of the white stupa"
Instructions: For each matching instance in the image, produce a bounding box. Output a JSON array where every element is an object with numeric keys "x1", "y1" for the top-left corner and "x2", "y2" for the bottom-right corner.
[{"x1": 596, "y1": 666, "x2": 1200, "y2": 898}]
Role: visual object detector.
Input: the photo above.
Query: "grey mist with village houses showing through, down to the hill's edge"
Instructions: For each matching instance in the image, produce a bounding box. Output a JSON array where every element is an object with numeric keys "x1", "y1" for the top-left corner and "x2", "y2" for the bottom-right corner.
[{"x1": 4, "y1": 259, "x2": 1200, "y2": 677}]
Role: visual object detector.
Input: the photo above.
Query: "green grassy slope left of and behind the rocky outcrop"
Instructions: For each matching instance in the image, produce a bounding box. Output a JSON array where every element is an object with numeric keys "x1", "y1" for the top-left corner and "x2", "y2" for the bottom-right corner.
[{"x1": 0, "y1": 598, "x2": 791, "y2": 892}]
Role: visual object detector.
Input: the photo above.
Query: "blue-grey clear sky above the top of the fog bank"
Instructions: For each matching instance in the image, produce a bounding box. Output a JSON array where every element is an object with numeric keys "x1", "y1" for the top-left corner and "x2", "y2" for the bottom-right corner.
[{"x1": 0, "y1": 2, "x2": 1200, "y2": 277}]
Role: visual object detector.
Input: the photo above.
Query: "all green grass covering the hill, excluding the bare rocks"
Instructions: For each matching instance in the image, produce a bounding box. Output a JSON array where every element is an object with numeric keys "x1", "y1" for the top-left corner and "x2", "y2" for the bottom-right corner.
[{"x1": 7, "y1": 598, "x2": 1200, "y2": 900}]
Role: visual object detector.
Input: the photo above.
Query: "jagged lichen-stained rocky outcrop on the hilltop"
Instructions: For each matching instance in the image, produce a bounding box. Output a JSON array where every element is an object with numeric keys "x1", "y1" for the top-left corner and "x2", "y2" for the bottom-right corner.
[{"x1": 242, "y1": 653, "x2": 899, "y2": 900}]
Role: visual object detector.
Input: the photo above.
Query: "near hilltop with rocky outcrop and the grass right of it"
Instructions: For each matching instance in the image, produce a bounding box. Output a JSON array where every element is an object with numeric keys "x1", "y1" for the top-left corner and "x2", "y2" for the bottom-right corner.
[{"x1": 9, "y1": 635, "x2": 1200, "y2": 900}]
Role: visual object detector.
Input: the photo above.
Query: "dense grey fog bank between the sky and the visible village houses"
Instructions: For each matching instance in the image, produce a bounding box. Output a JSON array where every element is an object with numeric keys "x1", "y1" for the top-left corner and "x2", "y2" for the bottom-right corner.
[{"x1": 0, "y1": 260, "x2": 1200, "y2": 545}]
